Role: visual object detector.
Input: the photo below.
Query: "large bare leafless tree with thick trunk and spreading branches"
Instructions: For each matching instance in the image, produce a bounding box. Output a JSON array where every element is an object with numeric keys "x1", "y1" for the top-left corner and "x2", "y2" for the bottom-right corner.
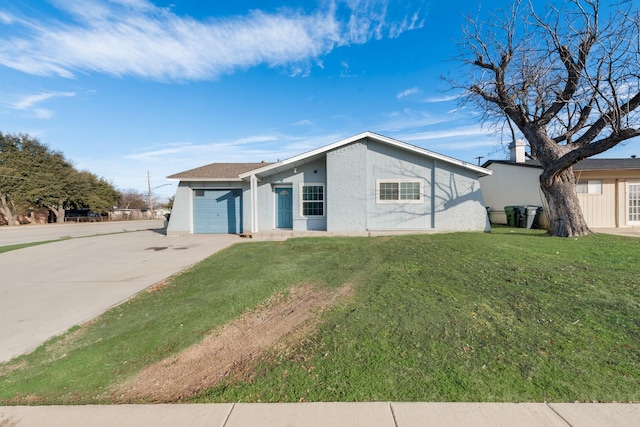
[{"x1": 449, "y1": 0, "x2": 640, "y2": 237}]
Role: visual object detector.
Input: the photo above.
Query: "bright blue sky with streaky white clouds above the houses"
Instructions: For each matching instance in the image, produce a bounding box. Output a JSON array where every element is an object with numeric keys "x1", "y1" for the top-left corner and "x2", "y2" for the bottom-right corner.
[{"x1": 0, "y1": 0, "x2": 640, "y2": 203}]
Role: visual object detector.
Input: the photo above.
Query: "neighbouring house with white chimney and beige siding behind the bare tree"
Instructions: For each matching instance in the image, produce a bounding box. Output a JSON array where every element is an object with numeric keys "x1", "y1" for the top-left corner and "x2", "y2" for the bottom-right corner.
[{"x1": 480, "y1": 140, "x2": 640, "y2": 227}]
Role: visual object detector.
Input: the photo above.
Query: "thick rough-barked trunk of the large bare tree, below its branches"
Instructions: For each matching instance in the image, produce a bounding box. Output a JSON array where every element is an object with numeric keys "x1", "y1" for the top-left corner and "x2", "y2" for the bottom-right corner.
[{"x1": 540, "y1": 167, "x2": 590, "y2": 237}]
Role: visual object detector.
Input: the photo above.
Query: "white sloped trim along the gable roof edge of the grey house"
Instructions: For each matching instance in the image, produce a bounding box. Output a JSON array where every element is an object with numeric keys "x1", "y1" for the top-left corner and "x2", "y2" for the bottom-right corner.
[{"x1": 238, "y1": 131, "x2": 493, "y2": 179}]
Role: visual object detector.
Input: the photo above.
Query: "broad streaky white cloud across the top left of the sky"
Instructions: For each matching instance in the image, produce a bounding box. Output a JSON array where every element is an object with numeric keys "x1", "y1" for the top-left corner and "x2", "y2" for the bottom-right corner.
[{"x1": 0, "y1": 0, "x2": 423, "y2": 80}]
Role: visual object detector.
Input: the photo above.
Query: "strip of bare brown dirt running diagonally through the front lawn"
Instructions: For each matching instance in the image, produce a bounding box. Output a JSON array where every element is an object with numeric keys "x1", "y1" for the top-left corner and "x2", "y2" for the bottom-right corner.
[{"x1": 114, "y1": 285, "x2": 351, "y2": 402}]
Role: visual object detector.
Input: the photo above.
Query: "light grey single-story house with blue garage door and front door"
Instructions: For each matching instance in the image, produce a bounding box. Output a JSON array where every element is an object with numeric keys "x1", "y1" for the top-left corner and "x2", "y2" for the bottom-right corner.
[{"x1": 167, "y1": 132, "x2": 491, "y2": 234}]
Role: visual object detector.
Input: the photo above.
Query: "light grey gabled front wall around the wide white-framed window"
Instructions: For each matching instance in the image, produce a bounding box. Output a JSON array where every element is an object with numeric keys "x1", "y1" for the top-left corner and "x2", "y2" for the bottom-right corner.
[{"x1": 327, "y1": 139, "x2": 489, "y2": 231}]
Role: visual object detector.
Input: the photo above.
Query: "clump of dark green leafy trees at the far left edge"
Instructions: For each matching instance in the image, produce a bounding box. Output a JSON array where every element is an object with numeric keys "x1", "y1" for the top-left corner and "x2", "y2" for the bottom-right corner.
[{"x1": 0, "y1": 133, "x2": 119, "y2": 225}]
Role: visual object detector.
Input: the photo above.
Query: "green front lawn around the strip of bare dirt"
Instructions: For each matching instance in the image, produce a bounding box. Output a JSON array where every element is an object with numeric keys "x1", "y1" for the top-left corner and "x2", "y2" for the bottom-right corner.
[{"x1": 0, "y1": 228, "x2": 640, "y2": 404}]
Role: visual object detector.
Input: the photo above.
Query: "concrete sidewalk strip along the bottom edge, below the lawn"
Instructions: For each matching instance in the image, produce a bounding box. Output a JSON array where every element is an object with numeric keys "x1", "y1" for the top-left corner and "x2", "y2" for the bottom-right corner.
[{"x1": 0, "y1": 402, "x2": 640, "y2": 427}]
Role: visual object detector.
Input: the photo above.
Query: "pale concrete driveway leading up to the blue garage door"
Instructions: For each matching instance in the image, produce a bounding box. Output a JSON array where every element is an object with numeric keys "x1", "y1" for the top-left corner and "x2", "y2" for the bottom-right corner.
[{"x1": 0, "y1": 224, "x2": 243, "y2": 362}]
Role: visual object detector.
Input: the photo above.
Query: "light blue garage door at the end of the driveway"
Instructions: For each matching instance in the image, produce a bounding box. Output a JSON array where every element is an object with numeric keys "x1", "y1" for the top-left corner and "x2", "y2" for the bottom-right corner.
[{"x1": 193, "y1": 190, "x2": 242, "y2": 234}]
